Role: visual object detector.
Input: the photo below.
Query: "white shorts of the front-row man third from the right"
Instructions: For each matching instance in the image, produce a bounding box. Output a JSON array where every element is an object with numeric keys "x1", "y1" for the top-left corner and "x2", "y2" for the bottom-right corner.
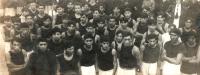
[{"x1": 142, "y1": 62, "x2": 157, "y2": 75}]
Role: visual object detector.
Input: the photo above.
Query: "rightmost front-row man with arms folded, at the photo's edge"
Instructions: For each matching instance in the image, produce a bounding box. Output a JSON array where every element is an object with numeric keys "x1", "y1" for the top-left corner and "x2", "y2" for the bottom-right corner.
[{"x1": 180, "y1": 32, "x2": 199, "y2": 75}]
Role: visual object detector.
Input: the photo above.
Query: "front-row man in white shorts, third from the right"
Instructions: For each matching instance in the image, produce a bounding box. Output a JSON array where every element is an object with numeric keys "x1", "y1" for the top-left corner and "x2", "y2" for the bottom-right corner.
[{"x1": 141, "y1": 34, "x2": 162, "y2": 75}]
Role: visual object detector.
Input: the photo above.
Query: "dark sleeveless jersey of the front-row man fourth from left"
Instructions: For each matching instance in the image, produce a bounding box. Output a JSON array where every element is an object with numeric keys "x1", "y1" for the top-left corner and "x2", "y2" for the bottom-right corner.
[{"x1": 81, "y1": 45, "x2": 97, "y2": 66}]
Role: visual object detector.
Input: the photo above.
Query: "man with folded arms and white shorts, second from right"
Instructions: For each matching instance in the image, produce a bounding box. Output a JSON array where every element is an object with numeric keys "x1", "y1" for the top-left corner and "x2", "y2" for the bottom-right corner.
[{"x1": 162, "y1": 29, "x2": 186, "y2": 75}]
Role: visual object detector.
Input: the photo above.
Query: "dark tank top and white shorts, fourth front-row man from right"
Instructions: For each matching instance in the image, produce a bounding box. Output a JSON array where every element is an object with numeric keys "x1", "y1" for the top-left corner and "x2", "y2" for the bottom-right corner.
[{"x1": 116, "y1": 45, "x2": 138, "y2": 75}]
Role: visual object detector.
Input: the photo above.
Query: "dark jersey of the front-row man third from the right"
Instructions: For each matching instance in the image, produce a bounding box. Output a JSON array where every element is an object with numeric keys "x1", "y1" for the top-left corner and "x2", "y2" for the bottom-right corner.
[{"x1": 143, "y1": 45, "x2": 161, "y2": 63}]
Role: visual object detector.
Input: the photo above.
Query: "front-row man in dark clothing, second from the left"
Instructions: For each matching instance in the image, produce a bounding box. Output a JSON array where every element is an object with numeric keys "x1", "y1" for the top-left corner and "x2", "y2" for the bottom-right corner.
[{"x1": 27, "y1": 38, "x2": 57, "y2": 75}]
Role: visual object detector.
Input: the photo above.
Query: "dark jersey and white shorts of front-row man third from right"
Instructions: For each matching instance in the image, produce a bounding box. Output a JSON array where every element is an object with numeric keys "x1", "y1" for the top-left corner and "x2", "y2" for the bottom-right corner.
[{"x1": 142, "y1": 44, "x2": 161, "y2": 75}]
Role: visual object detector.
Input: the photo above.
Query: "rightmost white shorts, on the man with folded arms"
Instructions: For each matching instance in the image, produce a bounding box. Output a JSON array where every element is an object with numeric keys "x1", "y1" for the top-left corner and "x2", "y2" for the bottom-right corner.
[{"x1": 162, "y1": 61, "x2": 181, "y2": 75}]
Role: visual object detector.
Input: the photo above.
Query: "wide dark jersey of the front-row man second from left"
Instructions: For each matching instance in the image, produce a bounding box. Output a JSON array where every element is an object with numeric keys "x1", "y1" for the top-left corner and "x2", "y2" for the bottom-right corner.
[{"x1": 28, "y1": 51, "x2": 57, "y2": 75}]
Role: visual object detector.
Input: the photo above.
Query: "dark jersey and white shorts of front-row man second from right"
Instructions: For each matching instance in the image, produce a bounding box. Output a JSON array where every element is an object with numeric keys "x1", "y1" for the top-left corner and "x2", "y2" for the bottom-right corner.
[{"x1": 162, "y1": 41, "x2": 185, "y2": 75}]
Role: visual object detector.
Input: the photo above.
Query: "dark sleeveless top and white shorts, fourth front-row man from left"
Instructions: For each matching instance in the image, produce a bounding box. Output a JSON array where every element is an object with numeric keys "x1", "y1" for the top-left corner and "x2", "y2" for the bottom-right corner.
[{"x1": 81, "y1": 45, "x2": 97, "y2": 75}]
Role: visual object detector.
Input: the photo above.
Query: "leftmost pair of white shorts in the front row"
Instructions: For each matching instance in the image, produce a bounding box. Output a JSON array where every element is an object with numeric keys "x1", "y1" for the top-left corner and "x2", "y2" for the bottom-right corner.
[{"x1": 81, "y1": 65, "x2": 96, "y2": 75}]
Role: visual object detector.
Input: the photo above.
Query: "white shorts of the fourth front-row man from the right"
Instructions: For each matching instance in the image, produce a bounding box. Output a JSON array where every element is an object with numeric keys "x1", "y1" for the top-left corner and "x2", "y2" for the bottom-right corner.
[{"x1": 116, "y1": 67, "x2": 136, "y2": 75}]
